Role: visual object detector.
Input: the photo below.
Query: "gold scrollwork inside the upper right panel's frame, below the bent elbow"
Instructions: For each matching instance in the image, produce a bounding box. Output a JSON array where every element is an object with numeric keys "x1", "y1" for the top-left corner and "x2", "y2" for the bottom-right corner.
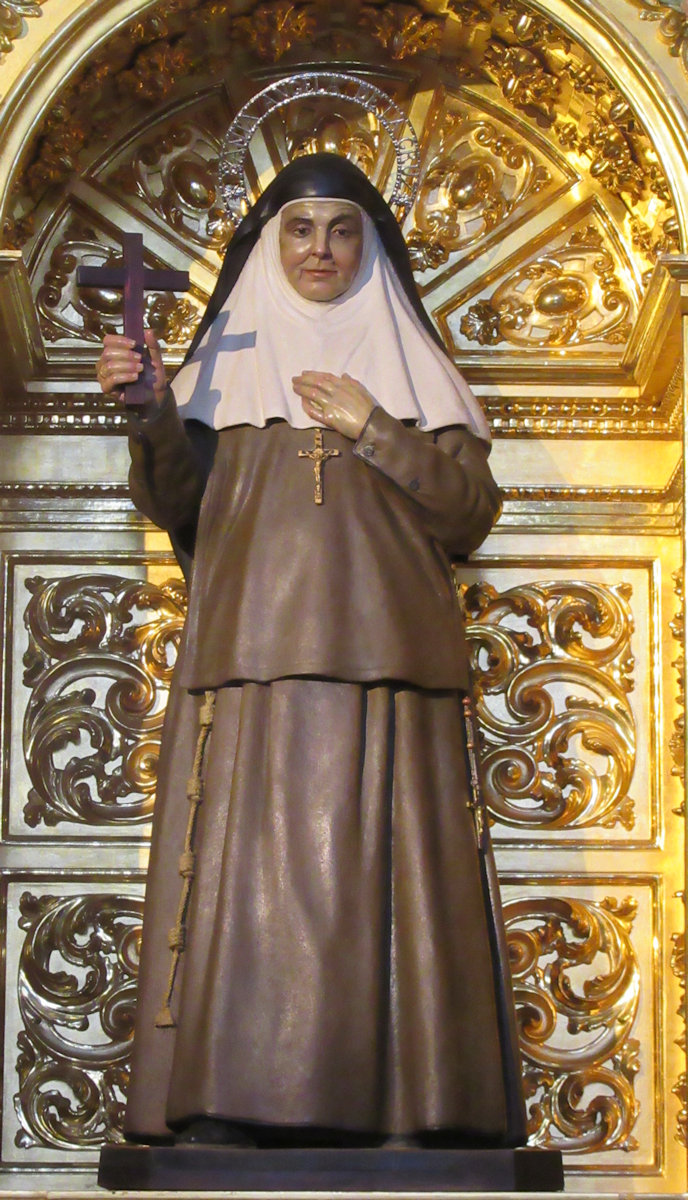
[{"x1": 461, "y1": 582, "x2": 635, "y2": 829}]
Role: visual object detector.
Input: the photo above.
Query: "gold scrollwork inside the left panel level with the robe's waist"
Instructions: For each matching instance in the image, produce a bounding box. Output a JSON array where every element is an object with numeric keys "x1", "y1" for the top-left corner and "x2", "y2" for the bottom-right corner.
[{"x1": 24, "y1": 575, "x2": 185, "y2": 826}]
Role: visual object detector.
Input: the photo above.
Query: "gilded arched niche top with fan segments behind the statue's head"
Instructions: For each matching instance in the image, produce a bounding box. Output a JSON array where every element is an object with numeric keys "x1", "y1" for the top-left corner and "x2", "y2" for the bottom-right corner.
[{"x1": 4, "y1": 0, "x2": 678, "y2": 433}]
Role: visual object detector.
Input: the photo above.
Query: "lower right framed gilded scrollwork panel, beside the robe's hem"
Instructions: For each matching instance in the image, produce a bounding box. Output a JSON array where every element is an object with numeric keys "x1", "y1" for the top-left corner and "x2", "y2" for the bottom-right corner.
[{"x1": 502, "y1": 870, "x2": 663, "y2": 1171}]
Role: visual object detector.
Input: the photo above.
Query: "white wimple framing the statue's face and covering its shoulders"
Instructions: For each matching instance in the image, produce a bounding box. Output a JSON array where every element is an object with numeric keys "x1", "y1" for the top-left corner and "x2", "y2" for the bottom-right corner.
[{"x1": 172, "y1": 200, "x2": 490, "y2": 442}]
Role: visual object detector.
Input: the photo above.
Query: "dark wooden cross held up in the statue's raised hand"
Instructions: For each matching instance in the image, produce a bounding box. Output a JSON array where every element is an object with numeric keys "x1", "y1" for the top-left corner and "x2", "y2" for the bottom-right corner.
[{"x1": 77, "y1": 233, "x2": 189, "y2": 407}]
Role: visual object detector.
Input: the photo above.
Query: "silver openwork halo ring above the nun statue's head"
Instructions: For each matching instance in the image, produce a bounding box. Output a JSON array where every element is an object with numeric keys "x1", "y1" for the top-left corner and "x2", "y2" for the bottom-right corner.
[{"x1": 217, "y1": 71, "x2": 420, "y2": 220}]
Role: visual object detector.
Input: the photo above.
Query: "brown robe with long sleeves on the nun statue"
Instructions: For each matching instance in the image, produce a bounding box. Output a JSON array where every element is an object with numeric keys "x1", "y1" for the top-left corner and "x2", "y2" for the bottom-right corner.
[{"x1": 121, "y1": 403, "x2": 524, "y2": 1144}]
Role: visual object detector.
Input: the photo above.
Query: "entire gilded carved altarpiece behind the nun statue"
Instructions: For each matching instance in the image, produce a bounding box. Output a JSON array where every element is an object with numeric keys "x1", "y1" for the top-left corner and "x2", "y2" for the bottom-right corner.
[{"x1": 0, "y1": 0, "x2": 688, "y2": 1194}]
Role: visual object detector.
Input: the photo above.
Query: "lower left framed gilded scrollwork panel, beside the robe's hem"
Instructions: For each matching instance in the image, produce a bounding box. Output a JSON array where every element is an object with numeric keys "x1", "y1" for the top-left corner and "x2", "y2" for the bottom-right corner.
[{"x1": 2, "y1": 871, "x2": 143, "y2": 1169}]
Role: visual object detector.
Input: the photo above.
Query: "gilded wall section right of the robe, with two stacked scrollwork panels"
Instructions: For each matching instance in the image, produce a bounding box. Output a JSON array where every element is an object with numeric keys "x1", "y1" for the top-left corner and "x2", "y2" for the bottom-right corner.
[{"x1": 470, "y1": 533, "x2": 684, "y2": 1189}]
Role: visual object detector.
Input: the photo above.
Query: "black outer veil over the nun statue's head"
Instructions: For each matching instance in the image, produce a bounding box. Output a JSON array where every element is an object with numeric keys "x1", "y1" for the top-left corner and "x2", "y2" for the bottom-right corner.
[{"x1": 184, "y1": 154, "x2": 447, "y2": 362}]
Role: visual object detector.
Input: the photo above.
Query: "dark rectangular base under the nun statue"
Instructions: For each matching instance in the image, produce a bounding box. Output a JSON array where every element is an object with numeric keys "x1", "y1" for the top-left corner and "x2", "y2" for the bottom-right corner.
[{"x1": 98, "y1": 1145, "x2": 564, "y2": 1193}]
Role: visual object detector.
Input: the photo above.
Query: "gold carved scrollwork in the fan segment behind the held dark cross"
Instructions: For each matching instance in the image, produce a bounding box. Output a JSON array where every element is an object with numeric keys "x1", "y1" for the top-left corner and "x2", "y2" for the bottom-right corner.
[{"x1": 36, "y1": 223, "x2": 199, "y2": 346}]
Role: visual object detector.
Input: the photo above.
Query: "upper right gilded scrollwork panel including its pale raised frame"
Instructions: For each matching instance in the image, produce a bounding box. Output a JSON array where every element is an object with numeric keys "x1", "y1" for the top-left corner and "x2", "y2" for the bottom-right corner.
[{"x1": 459, "y1": 558, "x2": 658, "y2": 846}]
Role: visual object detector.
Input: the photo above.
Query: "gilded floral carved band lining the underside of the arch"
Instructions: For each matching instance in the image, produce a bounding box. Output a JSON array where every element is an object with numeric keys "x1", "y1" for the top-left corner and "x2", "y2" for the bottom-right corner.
[{"x1": 6, "y1": 0, "x2": 675, "y2": 271}]
